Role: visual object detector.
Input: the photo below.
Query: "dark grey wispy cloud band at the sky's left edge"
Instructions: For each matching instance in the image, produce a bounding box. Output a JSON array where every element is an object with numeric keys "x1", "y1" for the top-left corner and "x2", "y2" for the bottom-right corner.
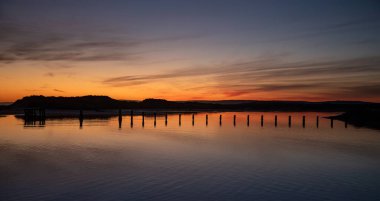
[{"x1": 0, "y1": 20, "x2": 201, "y2": 63}]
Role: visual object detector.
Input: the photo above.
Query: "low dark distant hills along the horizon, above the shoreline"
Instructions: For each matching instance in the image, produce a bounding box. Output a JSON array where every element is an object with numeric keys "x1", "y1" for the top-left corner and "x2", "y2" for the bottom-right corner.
[{"x1": 9, "y1": 96, "x2": 380, "y2": 111}]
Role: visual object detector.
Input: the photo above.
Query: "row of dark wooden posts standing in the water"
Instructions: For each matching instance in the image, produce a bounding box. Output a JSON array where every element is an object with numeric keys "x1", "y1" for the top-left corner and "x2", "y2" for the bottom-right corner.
[{"x1": 107, "y1": 110, "x2": 347, "y2": 128}]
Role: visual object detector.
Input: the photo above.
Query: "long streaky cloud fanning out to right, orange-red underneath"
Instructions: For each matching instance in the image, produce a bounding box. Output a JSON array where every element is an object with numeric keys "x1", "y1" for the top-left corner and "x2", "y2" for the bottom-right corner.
[{"x1": 103, "y1": 56, "x2": 380, "y2": 97}]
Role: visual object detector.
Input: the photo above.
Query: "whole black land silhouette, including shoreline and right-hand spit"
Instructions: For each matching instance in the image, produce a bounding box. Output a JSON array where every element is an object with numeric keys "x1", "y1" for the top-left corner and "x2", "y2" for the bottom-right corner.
[{"x1": 0, "y1": 95, "x2": 380, "y2": 129}]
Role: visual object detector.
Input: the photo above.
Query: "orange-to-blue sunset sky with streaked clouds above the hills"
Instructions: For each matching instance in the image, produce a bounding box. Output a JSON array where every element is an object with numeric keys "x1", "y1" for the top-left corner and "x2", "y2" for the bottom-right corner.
[{"x1": 0, "y1": 0, "x2": 380, "y2": 102}]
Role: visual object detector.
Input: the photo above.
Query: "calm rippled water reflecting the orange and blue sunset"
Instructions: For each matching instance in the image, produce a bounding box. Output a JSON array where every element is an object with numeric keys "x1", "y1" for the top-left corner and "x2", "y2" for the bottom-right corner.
[{"x1": 0, "y1": 113, "x2": 380, "y2": 201}]
